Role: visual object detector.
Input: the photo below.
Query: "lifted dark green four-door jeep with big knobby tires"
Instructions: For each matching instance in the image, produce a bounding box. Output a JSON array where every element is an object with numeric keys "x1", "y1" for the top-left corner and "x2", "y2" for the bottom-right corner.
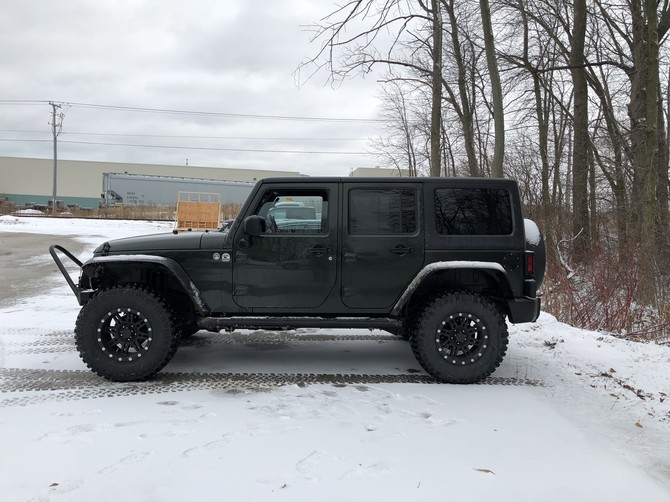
[{"x1": 50, "y1": 178, "x2": 545, "y2": 383}]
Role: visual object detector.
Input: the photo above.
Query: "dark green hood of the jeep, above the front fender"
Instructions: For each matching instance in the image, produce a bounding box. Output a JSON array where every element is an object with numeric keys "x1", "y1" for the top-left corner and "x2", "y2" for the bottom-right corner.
[{"x1": 93, "y1": 232, "x2": 204, "y2": 256}]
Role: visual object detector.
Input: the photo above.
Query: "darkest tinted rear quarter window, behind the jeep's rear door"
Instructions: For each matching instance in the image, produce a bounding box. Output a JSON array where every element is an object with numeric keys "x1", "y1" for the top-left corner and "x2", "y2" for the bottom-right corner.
[{"x1": 435, "y1": 188, "x2": 513, "y2": 235}]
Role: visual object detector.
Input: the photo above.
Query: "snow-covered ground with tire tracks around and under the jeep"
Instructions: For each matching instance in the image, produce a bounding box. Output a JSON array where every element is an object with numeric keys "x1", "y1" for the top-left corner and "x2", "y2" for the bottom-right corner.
[{"x1": 0, "y1": 216, "x2": 670, "y2": 502}]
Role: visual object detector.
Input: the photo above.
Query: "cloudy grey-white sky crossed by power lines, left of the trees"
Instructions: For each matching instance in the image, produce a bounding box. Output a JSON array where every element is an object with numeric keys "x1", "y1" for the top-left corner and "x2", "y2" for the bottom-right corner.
[{"x1": 0, "y1": 0, "x2": 386, "y2": 175}]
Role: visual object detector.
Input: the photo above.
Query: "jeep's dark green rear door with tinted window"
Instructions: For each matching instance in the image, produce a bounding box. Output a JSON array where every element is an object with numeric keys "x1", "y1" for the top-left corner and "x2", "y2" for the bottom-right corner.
[{"x1": 341, "y1": 182, "x2": 424, "y2": 309}]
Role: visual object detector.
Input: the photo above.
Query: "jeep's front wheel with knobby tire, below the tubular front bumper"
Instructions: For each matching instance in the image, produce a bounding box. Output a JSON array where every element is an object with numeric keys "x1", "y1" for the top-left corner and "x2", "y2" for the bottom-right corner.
[{"x1": 75, "y1": 286, "x2": 181, "y2": 382}]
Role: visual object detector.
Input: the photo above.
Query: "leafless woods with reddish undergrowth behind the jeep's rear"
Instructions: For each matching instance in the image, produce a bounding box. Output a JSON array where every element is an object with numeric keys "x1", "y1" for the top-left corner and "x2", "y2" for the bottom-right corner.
[{"x1": 301, "y1": 0, "x2": 670, "y2": 338}]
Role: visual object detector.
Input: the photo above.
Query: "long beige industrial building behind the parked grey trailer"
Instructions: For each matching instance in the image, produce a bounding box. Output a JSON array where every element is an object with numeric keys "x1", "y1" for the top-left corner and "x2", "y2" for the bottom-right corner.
[{"x1": 0, "y1": 157, "x2": 300, "y2": 208}]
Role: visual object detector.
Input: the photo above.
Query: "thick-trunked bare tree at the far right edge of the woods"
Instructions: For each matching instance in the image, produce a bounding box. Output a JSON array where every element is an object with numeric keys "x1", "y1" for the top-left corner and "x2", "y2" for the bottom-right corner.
[{"x1": 599, "y1": 0, "x2": 670, "y2": 303}]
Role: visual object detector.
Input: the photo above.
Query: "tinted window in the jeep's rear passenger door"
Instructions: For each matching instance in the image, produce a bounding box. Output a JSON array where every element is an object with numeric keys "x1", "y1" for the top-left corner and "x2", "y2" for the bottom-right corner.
[{"x1": 349, "y1": 188, "x2": 417, "y2": 235}]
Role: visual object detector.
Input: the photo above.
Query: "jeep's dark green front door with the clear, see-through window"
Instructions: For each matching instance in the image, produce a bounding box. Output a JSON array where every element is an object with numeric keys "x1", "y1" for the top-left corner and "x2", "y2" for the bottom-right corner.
[{"x1": 233, "y1": 183, "x2": 337, "y2": 309}]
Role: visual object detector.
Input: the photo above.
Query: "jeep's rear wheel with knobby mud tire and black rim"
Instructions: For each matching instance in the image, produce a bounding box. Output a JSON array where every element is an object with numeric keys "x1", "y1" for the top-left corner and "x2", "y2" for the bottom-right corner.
[{"x1": 410, "y1": 292, "x2": 509, "y2": 383}]
